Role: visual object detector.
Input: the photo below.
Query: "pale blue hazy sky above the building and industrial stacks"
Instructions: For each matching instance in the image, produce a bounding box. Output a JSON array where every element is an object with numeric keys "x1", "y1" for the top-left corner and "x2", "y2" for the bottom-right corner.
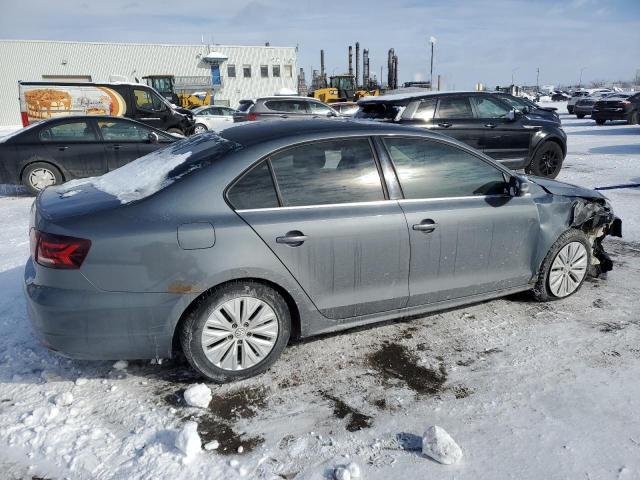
[{"x1": 0, "y1": 0, "x2": 640, "y2": 89}]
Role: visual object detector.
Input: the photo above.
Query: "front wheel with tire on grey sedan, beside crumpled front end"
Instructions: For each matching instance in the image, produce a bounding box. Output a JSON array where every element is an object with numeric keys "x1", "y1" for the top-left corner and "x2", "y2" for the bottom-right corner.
[{"x1": 533, "y1": 228, "x2": 591, "y2": 302}]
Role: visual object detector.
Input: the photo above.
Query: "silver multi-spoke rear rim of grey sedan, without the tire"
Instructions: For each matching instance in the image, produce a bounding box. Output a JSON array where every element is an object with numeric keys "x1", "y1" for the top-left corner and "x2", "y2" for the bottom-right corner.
[{"x1": 201, "y1": 296, "x2": 278, "y2": 371}]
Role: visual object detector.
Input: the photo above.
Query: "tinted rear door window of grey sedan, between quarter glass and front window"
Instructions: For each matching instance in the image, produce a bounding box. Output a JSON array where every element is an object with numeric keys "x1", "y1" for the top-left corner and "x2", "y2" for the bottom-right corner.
[{"x1": 271, "y1": 139, "x2": 384, "y2": 207}]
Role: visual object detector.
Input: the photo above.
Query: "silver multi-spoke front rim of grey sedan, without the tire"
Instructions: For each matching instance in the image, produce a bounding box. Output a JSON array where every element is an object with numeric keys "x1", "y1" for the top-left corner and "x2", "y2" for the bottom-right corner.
[{"x1": 549, "y1": 242, "x2": 588, "y2": 298}]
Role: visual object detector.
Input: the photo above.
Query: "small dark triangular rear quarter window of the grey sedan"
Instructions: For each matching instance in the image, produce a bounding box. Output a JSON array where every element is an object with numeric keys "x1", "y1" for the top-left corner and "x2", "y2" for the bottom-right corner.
[{"x1": 227, "y1": 161, "x2": 278, "y2": 210}]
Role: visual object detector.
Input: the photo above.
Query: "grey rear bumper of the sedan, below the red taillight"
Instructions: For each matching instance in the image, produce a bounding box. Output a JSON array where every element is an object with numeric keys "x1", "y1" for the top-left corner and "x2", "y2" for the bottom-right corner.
[{"x1": 24, "y1": 259, "x2": 182, "y2": 360}]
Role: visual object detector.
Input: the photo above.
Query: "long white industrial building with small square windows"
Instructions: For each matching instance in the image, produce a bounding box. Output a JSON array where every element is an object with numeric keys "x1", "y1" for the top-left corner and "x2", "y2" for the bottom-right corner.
[{"x1": 0, "y1": 40, "x2": 298, "y2": 125}]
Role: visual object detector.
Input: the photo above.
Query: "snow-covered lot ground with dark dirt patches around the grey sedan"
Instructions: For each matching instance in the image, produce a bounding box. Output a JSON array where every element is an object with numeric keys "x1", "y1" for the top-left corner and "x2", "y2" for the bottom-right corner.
[{"x1": 0, "y1": 109, "x2": 640, "y2": 480}]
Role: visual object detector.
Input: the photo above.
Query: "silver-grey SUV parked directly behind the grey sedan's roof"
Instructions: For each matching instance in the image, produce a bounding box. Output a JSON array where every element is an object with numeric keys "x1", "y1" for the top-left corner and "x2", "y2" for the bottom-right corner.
[{"x1": 233, "y1": 96, "x2": 339, "y2": 122}]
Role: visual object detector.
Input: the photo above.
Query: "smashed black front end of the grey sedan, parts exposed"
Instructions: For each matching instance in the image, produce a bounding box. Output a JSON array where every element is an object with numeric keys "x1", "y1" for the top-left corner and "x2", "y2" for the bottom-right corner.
[{"x1": 571, "y1": 197, "x2": 622, "y2": 277}]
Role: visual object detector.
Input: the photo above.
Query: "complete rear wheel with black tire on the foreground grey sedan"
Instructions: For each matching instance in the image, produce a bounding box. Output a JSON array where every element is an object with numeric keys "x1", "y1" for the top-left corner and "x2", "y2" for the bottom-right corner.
[{"x1": 178, "y1": 280, "x2": 291, "y2": 383}]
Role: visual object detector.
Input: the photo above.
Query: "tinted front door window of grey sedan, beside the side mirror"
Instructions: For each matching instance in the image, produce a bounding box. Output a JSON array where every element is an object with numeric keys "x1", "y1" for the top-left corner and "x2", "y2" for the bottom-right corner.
[{"x1": 384, "y1": 138, "x2": 508, "y2": 199}]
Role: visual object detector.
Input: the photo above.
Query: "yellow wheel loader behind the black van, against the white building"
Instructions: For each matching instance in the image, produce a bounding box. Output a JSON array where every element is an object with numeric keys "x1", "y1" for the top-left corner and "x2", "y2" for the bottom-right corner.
[{"x1": 142, "y1": 75, "x2": 211, "y2": 108}]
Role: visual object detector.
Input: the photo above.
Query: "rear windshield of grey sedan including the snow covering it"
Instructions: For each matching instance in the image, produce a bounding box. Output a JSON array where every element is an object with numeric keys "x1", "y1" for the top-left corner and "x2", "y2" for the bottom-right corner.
[{"x1": 57, "y1": 132, "x2": 242, "y2": 203}]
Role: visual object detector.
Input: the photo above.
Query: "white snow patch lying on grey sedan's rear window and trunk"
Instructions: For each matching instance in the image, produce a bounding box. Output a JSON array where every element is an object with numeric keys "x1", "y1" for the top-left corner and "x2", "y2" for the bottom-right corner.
[{"x1": 58, "y1": 149, "x2": 191, "y2": 203}]
